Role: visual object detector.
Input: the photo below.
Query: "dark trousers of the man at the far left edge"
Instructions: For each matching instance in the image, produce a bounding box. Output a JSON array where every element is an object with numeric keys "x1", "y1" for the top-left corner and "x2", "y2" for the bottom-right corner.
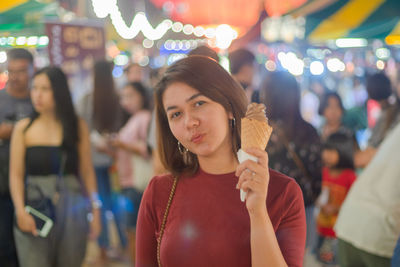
[{"x1": 0, "y1": 194, "x2": 18, "y2": 267}]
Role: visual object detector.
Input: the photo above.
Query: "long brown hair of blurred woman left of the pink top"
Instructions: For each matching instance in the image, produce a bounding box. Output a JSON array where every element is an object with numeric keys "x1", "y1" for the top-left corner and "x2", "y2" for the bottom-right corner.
[{"x1": 92, "y1": 60, "x2": 121, "y2": 132}]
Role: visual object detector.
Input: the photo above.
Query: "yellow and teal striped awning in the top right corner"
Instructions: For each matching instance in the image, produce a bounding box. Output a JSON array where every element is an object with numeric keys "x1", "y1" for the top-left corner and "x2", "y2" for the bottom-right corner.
[{"x1": 292, "y1": 0, "x2": 400, "y2": 44}]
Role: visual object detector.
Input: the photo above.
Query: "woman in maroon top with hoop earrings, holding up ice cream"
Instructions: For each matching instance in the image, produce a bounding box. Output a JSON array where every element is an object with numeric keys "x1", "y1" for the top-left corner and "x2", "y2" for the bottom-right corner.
[{"x1": 135, "y1": 56, "x2": 306, "y2": 267}]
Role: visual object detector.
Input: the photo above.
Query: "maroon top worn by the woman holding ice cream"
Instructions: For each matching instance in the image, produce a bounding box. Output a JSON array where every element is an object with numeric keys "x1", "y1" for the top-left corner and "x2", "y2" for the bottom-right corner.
[{"x1": 135, "y1": 170, "x2": 306, "y2": 267}]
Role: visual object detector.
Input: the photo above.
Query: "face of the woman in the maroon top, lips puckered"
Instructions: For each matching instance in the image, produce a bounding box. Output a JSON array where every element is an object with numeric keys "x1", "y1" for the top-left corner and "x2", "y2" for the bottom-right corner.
[{"x1": 162, "y1": 82, "x2": 232, "y2": 162}]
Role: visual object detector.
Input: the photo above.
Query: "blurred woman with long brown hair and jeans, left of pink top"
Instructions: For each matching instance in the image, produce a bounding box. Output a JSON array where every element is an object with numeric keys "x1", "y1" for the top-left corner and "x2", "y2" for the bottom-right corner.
[{"x1": 76, "y1": 60, "x2": 127, "y2": 262}]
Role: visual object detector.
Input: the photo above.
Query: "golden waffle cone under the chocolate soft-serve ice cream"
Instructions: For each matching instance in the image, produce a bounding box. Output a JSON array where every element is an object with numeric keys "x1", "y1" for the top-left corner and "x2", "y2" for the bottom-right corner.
[{"x1": 241, "y1": 117, "x2": 272, "y2": 150}]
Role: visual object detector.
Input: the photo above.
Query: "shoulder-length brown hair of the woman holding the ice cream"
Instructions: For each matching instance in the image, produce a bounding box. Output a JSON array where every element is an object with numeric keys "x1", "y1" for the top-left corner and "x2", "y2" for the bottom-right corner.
[{"x1": 155, "y1": 56, "x2": 247, "y2": 175}]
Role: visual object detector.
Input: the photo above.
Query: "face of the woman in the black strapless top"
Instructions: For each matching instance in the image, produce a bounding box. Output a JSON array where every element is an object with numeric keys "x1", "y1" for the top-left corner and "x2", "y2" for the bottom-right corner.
[{"x1": 31, "y1": 73, "x2": 55, "y2": 113}]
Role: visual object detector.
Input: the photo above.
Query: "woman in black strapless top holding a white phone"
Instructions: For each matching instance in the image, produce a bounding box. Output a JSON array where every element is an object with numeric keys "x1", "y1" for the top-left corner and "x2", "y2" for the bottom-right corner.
[{"x1": 10, "y1": 67, "x2": 100, "y2": 267}]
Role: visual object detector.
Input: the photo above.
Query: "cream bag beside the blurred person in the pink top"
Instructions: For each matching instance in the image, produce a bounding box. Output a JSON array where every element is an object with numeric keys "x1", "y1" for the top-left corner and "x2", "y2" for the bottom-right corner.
[{"x1": 131, "y1": 154, "x2": 153, "y2": 192}]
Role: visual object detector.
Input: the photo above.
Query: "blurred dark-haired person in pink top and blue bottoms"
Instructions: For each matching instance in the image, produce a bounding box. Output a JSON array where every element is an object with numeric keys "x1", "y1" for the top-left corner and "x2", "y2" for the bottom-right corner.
[{"x1": 111, "y1": 82, "x2": 151, "y2": 261}]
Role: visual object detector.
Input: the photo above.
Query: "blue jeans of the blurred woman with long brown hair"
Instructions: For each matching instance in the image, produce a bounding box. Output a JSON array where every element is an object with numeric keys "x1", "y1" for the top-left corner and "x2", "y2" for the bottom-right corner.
[{"x1": 95, "y1": 166, "x2": 127, "y2": 248}]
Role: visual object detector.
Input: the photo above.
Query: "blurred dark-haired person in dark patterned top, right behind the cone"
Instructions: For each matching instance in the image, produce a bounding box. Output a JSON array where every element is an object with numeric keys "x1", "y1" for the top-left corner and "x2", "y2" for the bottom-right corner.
[{"x1": 260, "y1": 71, "x2": 322, "y2": 250}]
